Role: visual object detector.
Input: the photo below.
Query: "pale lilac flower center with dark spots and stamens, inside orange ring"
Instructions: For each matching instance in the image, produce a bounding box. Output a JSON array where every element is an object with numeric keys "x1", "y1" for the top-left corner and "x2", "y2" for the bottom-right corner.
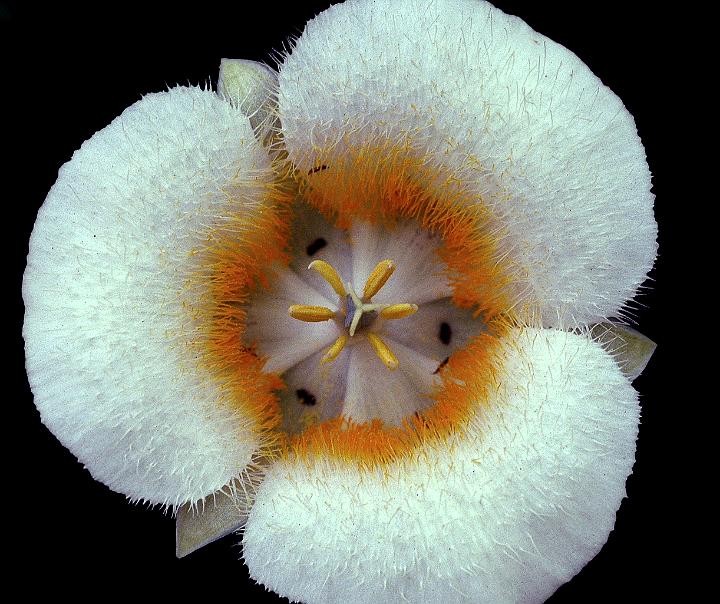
[{"x1": 243, "y1": 205, "x2": 484, "y2": 434}]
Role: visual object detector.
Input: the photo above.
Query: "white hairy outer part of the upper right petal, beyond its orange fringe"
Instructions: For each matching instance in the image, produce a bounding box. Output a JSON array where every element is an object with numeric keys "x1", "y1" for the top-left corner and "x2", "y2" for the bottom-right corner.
[{"x1": 279, "y1": 0, "x2": 657, "y2": 326}]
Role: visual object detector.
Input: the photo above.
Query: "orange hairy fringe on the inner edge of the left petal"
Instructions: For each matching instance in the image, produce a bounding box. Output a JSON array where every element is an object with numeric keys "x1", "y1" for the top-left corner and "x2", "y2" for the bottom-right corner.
[{"x1": 190, "y1": 183, "x2": 294, "y2": 457}]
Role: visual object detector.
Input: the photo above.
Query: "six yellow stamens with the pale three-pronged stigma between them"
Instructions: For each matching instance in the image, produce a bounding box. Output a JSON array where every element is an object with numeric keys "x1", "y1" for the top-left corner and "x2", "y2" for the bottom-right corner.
[{"x1": 288, "y1": 260, "x2": 418, "y2": 370}]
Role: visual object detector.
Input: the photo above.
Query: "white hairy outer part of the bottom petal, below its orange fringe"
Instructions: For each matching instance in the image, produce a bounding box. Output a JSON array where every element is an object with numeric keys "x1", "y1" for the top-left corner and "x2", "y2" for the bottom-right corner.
[{"x1": 243, "y1": 328, "x2": 639, "y2": 604}]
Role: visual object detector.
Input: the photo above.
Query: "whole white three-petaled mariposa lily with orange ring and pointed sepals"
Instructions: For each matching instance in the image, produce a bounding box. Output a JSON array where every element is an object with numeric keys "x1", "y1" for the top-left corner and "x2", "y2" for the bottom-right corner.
[{"x1": 23, "y1": 0, "x2": 656, "y2": 603}]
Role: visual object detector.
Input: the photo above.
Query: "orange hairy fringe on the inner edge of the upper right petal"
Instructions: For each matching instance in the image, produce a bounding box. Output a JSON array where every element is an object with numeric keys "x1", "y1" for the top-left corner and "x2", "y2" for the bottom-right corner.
[{"x1": 301, "y1": 142, "x2": 517, "y2": 319}]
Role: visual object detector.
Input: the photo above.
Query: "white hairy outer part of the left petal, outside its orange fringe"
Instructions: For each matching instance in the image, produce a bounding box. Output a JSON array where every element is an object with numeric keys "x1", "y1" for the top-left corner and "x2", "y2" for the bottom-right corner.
[{"x1": 23, "y1": 87, "x2": 271, "y2": 505}]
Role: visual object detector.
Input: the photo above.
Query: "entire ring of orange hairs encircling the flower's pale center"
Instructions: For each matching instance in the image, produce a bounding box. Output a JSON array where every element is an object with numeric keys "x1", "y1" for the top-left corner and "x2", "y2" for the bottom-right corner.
[{"x1": 189, "y1": 140, "x2": 512, "y2": 467}]
